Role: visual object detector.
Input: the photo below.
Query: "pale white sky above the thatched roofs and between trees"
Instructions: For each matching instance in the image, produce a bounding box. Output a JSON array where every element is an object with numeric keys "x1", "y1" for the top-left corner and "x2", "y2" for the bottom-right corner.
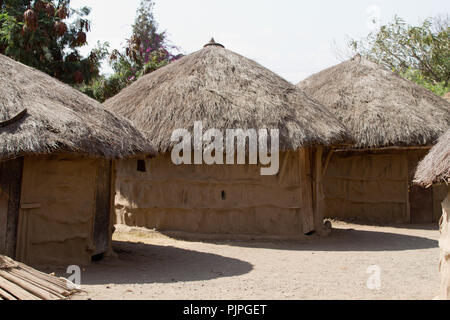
[{"x1": 71, "y1": 0, "x2": 450, "y2": 84}]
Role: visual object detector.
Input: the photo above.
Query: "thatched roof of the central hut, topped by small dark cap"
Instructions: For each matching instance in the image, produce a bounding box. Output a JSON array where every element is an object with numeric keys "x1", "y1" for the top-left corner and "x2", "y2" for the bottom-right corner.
[{"x1": 104, "y1": 42, "x2": 348, "y2": 152}]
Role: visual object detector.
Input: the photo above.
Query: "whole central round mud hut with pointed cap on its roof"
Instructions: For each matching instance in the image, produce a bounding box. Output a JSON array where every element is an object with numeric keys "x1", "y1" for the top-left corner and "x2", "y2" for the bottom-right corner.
[{"x1": 104, "y1": 40, "x2": 349, "y2": 236}]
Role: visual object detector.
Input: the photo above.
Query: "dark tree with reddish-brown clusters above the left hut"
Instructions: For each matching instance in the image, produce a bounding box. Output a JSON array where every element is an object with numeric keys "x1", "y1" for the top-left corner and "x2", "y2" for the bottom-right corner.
[{"x1": 0, "y1": 0, "x2": 107, "y2": 85}]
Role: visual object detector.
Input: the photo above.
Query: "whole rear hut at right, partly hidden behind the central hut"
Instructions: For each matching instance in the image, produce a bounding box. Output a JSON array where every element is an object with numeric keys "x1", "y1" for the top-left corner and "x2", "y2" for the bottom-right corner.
[{"x1": 298, "y1": 55, "x2": 450, "y2": 223}]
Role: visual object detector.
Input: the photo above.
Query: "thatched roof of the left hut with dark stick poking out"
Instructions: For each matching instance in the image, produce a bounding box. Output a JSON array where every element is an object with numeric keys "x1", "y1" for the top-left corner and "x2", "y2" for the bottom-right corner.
[{"x1": 0, "y1": 55, "x2": 153, "y2": 159}]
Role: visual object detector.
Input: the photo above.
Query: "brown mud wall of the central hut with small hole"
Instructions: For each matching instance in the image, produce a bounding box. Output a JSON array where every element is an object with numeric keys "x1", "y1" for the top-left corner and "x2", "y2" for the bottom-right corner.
[{"x1": 115, "y1": 150, "x2": 312, "y2": 235}]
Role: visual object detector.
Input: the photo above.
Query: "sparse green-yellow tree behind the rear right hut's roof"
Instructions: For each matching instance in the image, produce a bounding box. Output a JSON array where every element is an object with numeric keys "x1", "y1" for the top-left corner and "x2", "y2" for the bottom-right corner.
[{"x1": 348, "y1": 16, "x2": 450, "y2": 95}]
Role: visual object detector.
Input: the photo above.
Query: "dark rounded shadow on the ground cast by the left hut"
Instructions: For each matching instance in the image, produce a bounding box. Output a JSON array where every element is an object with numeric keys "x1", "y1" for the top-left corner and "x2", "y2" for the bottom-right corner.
[{"x1": 75, "y1": 241, "x2": 253, "y2": 285}]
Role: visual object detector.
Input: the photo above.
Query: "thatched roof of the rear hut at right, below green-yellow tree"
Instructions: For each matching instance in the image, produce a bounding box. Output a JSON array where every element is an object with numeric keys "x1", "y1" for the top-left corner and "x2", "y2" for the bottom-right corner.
[{"x1": 298, "y1": 56, "x2": 450, "y2": 148}]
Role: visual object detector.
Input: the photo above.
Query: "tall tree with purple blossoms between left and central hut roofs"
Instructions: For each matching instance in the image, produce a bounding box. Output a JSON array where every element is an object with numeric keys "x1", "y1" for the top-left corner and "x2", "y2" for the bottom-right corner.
[{"x1": 81, "y1": 0, "x2": 181, "y2": 102}]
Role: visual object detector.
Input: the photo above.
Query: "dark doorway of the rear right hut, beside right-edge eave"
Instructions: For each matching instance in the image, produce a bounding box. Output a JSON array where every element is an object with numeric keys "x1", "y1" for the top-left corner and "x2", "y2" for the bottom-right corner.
[{"x1": 409, "y1": 185, "x2": 433, "y2": 223}]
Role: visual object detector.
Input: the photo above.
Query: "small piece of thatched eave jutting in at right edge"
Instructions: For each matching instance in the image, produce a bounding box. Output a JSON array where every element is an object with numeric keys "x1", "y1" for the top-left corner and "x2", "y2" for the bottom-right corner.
[{"x1": 415, "y1": 130, "x2": 450, "y2": 186}]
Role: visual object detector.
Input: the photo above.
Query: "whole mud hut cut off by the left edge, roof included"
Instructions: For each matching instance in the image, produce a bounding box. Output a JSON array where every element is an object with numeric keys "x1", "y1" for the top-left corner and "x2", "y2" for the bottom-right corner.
[{"x1": 0, "y1": 55, "x2": 154, "y2": 265}]
